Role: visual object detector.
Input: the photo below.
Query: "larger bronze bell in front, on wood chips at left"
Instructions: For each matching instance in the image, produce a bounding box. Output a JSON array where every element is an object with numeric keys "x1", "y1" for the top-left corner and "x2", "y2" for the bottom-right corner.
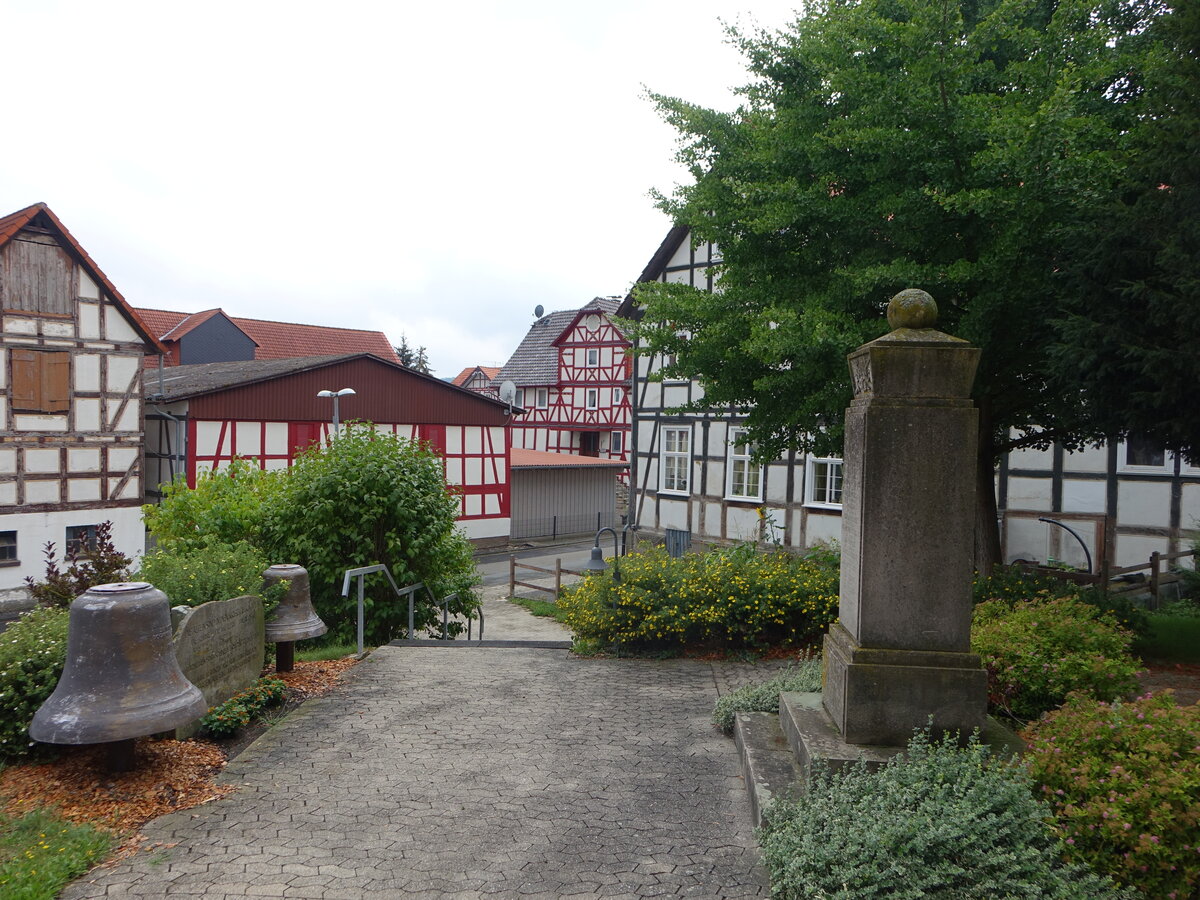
[{"x1": 29, "y1": 581, "x2": 208, "y2": 744}]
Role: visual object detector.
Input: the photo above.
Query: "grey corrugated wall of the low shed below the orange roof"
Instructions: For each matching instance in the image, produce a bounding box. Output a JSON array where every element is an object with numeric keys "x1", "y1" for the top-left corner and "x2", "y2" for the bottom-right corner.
[{"x1": 510, "y1": 467, "x2": 620, "y2": 539}]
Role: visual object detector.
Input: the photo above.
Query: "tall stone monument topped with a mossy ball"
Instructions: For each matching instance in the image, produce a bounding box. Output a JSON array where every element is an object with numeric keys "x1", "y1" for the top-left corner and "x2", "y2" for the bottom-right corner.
[{"x1": 822, "y1": 290, "x2": 988, "y2": 746}]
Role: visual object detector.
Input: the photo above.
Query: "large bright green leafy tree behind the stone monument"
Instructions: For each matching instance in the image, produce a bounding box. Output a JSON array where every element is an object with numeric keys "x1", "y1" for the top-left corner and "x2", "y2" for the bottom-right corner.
[{"x1": 637, "y1": 0, "x2": 1166, "y2": 563}]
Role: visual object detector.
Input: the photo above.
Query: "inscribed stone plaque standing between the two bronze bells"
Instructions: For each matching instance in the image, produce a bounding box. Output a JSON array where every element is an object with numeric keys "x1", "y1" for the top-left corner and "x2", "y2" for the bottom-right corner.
[{"x1": 175, "y1": 596, "x2": 264, "y2": 740}]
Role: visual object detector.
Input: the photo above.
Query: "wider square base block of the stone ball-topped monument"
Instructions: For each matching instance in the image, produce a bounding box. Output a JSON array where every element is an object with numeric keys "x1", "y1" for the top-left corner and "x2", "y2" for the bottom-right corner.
[{"x1": 823, "y1": 623, "x2": 988, "y2": 746}]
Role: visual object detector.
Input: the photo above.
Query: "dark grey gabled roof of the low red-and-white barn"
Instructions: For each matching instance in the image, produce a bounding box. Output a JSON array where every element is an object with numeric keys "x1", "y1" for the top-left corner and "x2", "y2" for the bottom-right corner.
[{"x1": 145, "y1": 353, "x2": 508, "y2": 409}]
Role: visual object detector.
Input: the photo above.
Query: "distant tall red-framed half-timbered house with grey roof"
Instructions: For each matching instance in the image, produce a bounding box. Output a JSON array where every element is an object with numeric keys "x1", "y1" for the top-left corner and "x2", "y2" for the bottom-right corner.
[{"x1": 492, "y1": 298, "x2": 631, "y2": 472}]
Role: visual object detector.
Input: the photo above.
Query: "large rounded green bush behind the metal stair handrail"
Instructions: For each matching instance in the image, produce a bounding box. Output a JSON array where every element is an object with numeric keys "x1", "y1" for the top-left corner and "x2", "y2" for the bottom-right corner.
[{"x1": 264, "y1": 425, "x2": 479, "y2": 644}]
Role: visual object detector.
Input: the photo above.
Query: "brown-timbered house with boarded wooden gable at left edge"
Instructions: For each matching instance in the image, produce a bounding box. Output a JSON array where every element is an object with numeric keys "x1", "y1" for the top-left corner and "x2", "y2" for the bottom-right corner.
[{"x1": 0, "y1": 203, "x2": 163, "y2": 598}]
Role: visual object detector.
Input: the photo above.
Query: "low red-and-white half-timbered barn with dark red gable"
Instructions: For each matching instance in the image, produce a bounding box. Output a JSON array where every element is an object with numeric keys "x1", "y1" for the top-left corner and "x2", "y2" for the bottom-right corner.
[{"x1": 146, "y1": 353, "x2": 511, "y2": 541}]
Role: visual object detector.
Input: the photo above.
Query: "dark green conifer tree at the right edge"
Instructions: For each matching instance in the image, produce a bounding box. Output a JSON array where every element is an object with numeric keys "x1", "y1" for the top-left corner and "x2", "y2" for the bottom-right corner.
[{"x1": 1055, "y1": 2, "x2": 1200, "y2": 460}]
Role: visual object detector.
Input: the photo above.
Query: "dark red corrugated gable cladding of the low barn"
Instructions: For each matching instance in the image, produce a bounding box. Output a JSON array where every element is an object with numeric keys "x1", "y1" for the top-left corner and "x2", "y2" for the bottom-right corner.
[{"x1": 188, "y1": 359, "x2": 506, "y2": 425}]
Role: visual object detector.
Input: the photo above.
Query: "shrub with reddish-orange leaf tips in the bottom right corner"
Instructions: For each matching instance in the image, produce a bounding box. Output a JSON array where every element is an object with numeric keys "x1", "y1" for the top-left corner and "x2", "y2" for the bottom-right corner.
[{"x1": 1022, "y1": 694, "x2": 1200, "y2": 898}]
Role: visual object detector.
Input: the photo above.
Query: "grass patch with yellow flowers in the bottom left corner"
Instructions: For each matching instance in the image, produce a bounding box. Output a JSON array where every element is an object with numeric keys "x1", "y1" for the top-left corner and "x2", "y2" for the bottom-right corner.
[{"x1": 0, "y1": 810, "x2": 112, "y2": 900}]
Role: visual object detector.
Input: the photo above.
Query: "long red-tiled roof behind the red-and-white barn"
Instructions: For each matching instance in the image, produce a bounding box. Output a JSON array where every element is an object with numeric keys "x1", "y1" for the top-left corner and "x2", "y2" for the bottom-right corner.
[{"x1": 138, "y1": 308, "x2": 400, "y2": 362}]
